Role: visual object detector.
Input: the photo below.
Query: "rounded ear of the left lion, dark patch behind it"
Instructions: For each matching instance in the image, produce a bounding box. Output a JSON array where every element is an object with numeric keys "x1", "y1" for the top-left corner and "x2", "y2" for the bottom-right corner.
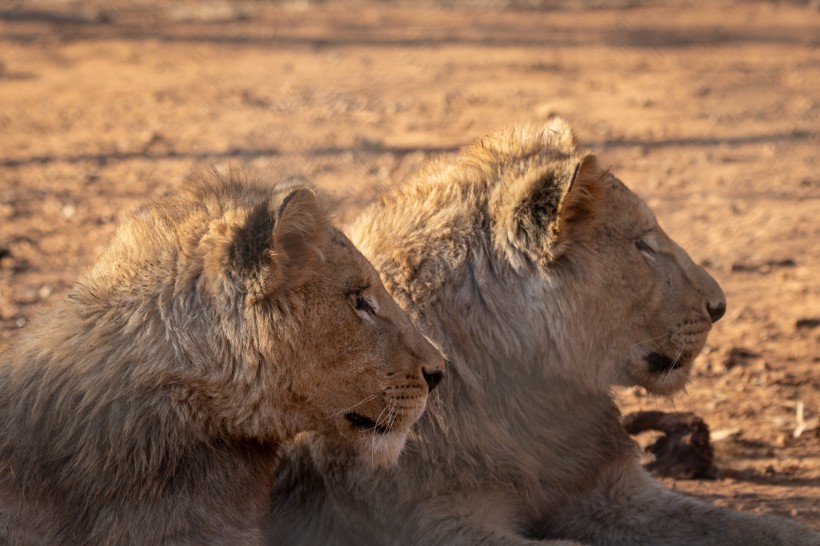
[{"x1": 228, "y1": 187, "x2": 328, "y2": 302}]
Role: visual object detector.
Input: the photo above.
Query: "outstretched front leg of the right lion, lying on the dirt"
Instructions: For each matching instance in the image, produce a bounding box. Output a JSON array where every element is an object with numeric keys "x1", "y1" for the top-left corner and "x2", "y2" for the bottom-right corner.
[{"x1": 550, "y1": 461, "x2": 820, "y2": 546}]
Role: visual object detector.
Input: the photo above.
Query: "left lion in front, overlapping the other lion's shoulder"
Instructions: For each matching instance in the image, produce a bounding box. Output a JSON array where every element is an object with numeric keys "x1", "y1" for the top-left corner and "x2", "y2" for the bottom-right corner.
[{"x1": 0, "y1": 170, "x2": 444, "y2": 545}]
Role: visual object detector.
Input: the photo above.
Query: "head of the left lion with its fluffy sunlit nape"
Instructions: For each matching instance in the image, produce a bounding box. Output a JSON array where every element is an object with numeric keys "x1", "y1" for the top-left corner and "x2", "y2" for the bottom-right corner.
[{"x1": 75, "y1": 172, "x2": 443, "y2": 464}]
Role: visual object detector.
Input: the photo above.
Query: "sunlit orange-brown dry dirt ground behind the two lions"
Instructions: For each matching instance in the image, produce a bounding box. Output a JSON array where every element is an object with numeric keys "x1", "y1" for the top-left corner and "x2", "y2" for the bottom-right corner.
[{"x1": 0, "y1": 0, "x2": 820, "y2": 529}]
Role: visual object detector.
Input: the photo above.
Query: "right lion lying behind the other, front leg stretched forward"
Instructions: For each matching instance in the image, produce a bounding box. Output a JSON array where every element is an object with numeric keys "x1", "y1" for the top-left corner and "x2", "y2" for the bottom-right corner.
[{"x1": 268, "y1": 119, "x2": 820, "y2": 546}]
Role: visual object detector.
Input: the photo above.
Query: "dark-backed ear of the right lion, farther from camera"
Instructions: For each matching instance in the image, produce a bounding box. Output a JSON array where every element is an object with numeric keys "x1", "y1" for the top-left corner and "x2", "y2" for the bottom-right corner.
[{"x1": 493, "y1": 151, "x2": 597, "y2": 268}]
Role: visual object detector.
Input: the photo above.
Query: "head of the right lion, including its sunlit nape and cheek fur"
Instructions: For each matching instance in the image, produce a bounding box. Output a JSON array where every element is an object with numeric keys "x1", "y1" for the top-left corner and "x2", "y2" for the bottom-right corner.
[{"x1": 351, "y1": 119, "x2": 726, "y2": 394}]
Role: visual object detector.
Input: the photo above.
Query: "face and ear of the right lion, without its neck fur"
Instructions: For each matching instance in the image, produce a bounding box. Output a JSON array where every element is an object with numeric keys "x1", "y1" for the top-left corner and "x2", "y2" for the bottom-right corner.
[{"x1": 481, "y1": 120, "x2": 726, "y2": 394}]
